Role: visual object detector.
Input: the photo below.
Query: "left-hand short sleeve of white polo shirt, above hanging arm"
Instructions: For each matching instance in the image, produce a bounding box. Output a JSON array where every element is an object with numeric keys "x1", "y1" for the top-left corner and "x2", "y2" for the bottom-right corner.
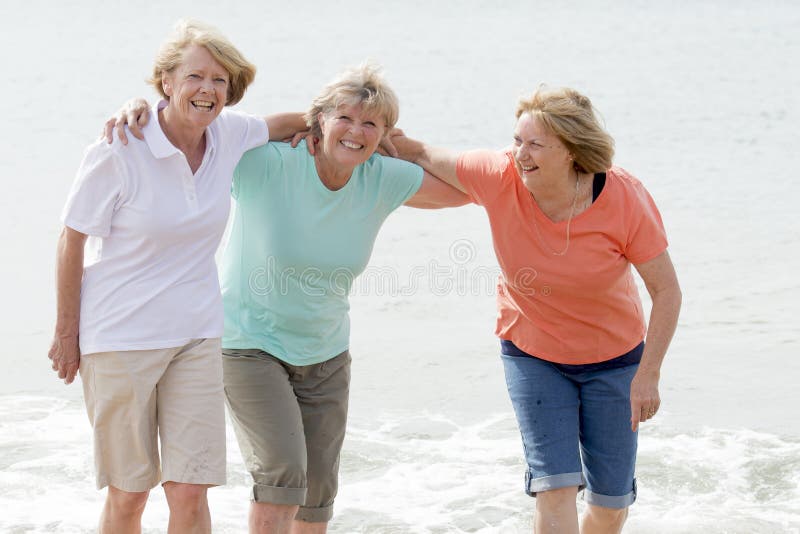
[{"x1": 61, "y1": 141, "x2": 124, "y2": 237}]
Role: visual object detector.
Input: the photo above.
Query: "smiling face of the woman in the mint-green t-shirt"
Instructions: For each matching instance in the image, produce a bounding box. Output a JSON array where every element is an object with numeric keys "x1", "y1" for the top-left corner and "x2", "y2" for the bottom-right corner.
[{"x1": 319, "y1": 103, "x2": 386, "y2": 168}]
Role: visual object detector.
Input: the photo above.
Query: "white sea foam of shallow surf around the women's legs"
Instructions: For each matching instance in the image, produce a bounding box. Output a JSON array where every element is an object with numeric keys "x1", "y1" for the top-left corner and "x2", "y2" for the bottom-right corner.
[{"x1": 0, "y1": 396, "x2": 800, "y2": 534}]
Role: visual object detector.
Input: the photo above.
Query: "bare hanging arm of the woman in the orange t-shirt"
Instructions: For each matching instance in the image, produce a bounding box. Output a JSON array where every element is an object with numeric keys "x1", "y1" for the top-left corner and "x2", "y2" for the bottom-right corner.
[{"x1": 631, "y1": 251, "x2": 681, "y2": 432}]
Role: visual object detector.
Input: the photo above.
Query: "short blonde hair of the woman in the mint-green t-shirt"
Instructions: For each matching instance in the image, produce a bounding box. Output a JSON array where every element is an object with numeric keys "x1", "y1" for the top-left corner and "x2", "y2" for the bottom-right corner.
[{"x1": 304, "y1": 62, "x2": 400, "y2": 137}]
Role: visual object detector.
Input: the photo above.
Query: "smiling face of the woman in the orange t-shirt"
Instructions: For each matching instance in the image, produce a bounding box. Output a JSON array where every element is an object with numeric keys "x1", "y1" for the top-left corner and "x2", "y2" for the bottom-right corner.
[{"x1": 513, "y1": 113, "x2": 573, "y2": 189}]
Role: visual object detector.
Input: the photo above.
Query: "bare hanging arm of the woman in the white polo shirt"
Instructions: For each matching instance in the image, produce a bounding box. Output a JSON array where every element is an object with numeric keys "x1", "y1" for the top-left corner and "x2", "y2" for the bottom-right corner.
[{"x1": 48, "y1": 228, "x2": 86, "y2": 384}]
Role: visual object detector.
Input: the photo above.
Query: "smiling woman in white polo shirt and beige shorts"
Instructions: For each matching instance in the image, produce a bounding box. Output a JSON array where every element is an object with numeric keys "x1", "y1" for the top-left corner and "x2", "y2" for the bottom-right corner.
[{"x1": 49, "y1": 21, "x2": 304, "y2": 533}]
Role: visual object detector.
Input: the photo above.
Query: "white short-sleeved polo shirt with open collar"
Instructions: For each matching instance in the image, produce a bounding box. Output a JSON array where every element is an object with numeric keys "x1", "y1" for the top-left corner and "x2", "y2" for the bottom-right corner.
[{"x1": 62, "y1": 104, "x2": 269, "y2": 354}]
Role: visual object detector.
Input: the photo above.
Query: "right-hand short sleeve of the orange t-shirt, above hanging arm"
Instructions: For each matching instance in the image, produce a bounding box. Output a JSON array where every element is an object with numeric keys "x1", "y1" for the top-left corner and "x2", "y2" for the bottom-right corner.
[{"x1": 625, "y1": 172, "x2": 668, "y2": 264}]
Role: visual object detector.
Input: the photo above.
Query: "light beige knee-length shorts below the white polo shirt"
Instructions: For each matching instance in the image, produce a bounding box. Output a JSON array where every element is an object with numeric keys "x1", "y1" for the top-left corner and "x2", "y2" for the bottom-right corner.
[{"x1": 80, "y1": 338, "x2": 226, "y2": 492}]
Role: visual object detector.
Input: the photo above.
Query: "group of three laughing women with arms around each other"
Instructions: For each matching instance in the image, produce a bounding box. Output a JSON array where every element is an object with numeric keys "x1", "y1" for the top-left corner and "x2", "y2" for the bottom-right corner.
[{"x1": 50, "y1": 18, "x2": 680, "y2": 533}]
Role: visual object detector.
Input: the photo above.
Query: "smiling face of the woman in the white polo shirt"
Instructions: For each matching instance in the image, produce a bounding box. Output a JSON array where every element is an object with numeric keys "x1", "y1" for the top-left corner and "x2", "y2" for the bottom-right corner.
[{"x1": 162, "y1": 45, "x2": 229, "y2": 128}]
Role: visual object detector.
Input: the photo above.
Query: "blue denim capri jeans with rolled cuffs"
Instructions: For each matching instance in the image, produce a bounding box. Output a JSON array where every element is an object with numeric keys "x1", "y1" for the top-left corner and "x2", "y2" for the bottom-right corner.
[{"x1": 502, "y1": 354, "x2": 639, "y2": 509}]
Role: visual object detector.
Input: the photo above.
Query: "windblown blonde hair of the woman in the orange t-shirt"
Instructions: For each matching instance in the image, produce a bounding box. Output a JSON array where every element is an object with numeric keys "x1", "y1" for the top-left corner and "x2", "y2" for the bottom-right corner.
[{"x1": 517, "y1": 85, "x2": 614, "y2": 173}]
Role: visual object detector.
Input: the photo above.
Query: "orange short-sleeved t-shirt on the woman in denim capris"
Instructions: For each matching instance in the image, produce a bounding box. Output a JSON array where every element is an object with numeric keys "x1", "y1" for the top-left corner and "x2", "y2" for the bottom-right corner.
[{"x1": 457, "y1": 150, "x2": 667, "y2": 365}]
